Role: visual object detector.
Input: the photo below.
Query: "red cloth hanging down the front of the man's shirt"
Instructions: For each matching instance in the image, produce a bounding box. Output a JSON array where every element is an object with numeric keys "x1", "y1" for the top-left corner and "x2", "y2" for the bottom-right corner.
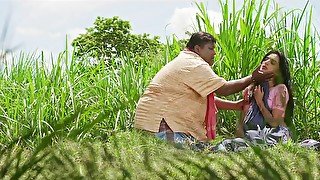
[{"x1": 205, "y1": 92, "x2": 218, "y2": 140}]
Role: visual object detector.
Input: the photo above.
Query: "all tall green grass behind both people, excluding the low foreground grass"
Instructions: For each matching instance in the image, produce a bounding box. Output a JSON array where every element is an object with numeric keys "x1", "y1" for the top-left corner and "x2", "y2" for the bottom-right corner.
[{"x1": 0, "y1": 1, "x2": 320, "y2": 145}]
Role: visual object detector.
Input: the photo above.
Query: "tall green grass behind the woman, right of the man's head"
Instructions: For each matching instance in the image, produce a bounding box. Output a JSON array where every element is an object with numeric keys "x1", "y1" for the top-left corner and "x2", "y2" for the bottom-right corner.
[{"x1": 191, "y1": 0, "x2": 320, "y2": 139}]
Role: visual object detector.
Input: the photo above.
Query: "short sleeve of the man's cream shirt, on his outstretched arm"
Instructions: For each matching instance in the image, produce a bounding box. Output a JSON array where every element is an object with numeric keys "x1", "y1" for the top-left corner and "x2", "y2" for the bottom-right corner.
[{"x1": 181, "y1": 64, "x2": 227, "y2": 97}]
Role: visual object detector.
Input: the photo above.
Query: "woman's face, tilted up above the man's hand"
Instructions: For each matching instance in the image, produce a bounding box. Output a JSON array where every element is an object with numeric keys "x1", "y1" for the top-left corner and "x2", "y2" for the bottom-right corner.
[{"x1": 260, "y1": 54, "x2": 280, "y2": 74}]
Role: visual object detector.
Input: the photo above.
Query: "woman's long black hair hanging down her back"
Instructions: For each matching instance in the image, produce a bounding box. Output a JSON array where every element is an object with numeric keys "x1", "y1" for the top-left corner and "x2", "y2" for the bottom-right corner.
[{"x1": 261, "y1": 50, "x2": 294, "y2": 130}]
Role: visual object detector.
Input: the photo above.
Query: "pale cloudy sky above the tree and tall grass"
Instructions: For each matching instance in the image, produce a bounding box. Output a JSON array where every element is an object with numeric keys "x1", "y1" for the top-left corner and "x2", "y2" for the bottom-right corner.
[{"x1": 0, "y1": 0, "x2": 320, "y2": 57}]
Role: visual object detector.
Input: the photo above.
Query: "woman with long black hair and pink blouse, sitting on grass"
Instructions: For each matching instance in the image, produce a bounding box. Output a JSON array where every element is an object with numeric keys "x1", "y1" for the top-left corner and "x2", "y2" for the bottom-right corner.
[{"x1": 236, "y1": 50, "x2": 294, "y2": 139}]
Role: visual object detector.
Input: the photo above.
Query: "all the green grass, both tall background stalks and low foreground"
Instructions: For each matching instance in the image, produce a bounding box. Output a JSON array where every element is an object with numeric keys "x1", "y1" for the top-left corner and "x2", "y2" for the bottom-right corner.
[{"x1": 0, "y1": 1, "x2": 320, "y2": 179}]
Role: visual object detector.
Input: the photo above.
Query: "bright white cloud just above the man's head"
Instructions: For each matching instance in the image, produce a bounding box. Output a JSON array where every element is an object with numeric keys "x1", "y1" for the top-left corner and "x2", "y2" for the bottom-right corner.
[{"x1": 167, "y1": 8, "x2": 222, "y2": 39}]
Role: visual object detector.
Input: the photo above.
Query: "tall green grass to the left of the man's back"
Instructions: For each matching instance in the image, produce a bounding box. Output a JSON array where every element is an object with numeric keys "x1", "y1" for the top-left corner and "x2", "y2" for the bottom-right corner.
[{"x1": 0, "y1": 48, "x2": 165, "y2": 144}]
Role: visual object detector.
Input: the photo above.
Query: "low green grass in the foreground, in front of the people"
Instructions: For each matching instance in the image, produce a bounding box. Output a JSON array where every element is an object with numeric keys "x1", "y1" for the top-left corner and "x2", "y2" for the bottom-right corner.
[{"x1": 0, "y1": 131, "x2": 320, "y2": 179}]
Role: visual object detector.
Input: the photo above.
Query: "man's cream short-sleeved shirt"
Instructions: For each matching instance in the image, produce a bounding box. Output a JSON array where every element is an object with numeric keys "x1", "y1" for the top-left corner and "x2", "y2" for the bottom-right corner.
[{"x1": 135, "y1": 51, "x2": 225, "y2": 139}]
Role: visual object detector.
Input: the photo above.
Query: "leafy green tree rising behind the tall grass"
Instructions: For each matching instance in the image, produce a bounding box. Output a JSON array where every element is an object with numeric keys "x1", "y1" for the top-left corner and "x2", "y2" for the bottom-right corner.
[{"x1": 72, "y1": 17, "x2": 161, "y2": 61}]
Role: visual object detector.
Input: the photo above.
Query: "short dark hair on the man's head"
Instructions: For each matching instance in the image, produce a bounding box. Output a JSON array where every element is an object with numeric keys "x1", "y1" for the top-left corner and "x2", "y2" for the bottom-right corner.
[{"x1": 186, "y1": 31, "x2": 216, "y2": 50}]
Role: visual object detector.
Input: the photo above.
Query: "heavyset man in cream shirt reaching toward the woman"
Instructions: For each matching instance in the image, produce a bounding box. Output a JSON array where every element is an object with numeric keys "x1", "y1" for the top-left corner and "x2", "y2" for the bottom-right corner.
[{"x1": 134, "y1": 32, "x2": 272, "y2": 141}]
